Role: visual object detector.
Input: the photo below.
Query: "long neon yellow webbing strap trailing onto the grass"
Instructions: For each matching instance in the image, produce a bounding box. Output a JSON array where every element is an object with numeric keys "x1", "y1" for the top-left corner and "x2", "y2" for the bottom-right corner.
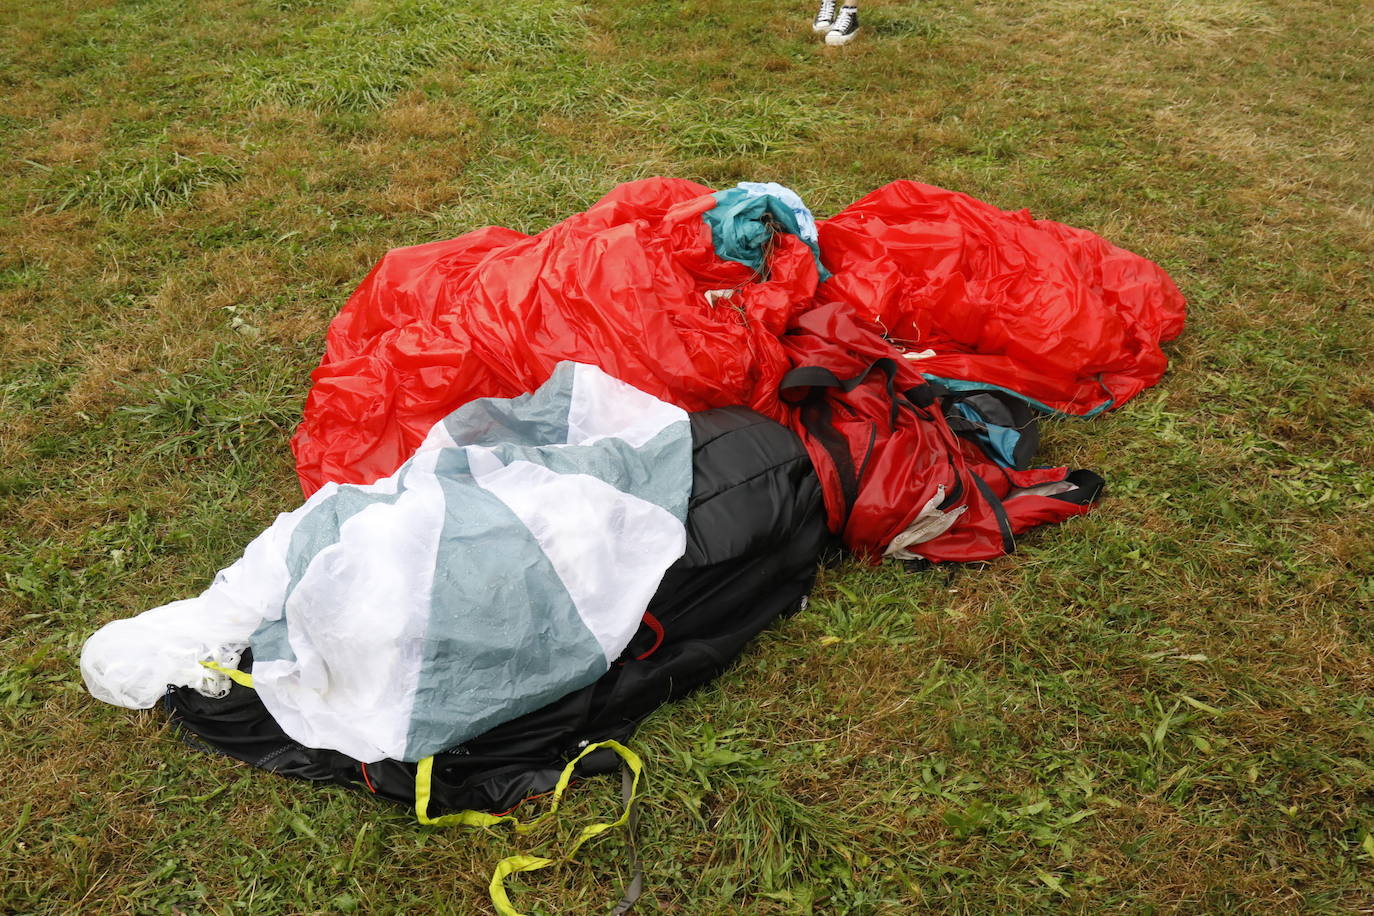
[{"x1": 415, "y1": 742, "x2": 644, "y2": 916}]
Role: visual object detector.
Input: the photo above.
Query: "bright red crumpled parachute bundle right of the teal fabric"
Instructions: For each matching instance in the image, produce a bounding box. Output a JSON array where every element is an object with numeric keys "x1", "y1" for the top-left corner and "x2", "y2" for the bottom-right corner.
[{"x1": 820, "y1": 181, "x2": 1184, "y2": 415}]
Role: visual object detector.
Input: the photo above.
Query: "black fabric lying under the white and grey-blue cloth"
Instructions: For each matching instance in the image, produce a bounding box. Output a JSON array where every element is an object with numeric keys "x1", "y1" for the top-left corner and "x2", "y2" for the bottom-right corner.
[{"x1": 166, "y1": 408, "x2": 833, "y2": 814}]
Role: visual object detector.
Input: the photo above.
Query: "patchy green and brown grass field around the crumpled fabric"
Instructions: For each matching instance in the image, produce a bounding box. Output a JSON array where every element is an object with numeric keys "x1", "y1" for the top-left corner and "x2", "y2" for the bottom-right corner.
[{"x1": 0, "y1": 0, "x2": 1374, "y2": 916}]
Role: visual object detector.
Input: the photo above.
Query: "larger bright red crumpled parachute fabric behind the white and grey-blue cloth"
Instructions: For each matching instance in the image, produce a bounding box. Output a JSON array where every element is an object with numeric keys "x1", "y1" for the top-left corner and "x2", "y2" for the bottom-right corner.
[{"x1": 291, "y1": 179, "x2": 818, "y2": 496}]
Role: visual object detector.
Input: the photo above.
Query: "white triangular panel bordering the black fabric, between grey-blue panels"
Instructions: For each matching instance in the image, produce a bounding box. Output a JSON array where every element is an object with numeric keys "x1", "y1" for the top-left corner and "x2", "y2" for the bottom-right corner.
[{"x1": 469, "y1": 461, "x2": 687, "y2": 665}]
